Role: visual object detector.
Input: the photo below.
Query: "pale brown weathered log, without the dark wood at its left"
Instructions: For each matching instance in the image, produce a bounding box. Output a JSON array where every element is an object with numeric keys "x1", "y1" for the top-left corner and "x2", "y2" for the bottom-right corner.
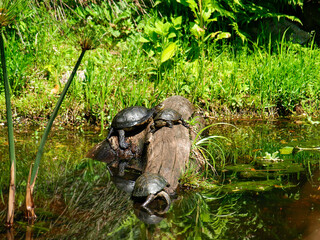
[{"x1": 144, "y1": 96, "x2": 195, "y2": 194}]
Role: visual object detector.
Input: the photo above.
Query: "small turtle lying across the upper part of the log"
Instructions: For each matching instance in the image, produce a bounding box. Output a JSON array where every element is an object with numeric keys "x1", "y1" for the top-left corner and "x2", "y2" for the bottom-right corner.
[{"x1": 151, "y1": 108, "x2": 189, "y2": 132}]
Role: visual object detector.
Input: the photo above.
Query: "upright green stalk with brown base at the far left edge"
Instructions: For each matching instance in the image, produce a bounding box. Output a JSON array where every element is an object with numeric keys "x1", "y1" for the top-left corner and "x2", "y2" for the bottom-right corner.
[{"x1": 0, "y1": 29, "x2": 16, "y2": 227}]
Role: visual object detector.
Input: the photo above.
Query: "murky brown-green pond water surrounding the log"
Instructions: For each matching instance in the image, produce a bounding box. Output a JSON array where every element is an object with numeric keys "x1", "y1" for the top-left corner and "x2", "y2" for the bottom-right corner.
[{"x1": 0, "y1": 120, "x2": 320, "y2": 240}]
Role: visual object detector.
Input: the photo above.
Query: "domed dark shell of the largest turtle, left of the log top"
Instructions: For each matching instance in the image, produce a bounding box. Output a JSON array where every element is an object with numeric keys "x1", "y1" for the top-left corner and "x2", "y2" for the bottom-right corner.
[{"x1": 111, "y1": 106, "x2": 155, "y2": 129}]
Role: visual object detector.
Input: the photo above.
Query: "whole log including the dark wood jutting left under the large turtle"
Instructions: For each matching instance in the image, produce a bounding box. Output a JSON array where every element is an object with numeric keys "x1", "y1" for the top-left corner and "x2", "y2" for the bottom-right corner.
[{"x1": 86, "y1": 96, "x2": 204, "y2": 194}]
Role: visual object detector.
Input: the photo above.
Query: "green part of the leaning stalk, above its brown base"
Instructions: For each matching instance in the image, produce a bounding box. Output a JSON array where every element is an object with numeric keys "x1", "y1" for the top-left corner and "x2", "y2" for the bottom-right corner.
[{"x1": 30, "y1": 49, "x2": 86, "y2": 185}]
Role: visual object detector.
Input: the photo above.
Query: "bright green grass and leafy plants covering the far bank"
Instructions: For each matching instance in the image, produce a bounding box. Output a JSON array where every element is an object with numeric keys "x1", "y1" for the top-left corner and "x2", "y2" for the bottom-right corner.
[{"x1": 0, "y1": 1, "x2": 320, "y2": 130}]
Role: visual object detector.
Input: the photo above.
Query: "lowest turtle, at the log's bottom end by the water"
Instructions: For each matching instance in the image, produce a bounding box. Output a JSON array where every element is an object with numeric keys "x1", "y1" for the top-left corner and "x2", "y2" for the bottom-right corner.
[{"x1": 132, "y1": 172, "x2": 171, "y2": 211}]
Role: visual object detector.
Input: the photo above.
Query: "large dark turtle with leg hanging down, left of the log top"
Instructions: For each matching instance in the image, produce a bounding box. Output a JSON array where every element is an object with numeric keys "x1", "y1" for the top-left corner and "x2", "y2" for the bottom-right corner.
[{"x1": 107, "y1": 104, "x2": 163, "y2": 149}]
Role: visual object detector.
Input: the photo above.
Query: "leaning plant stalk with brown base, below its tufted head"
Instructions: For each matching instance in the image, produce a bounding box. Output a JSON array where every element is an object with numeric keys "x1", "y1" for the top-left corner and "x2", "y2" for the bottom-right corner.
[{"x1": 26, "y1": 49, "x2": 87, "y2": 219}]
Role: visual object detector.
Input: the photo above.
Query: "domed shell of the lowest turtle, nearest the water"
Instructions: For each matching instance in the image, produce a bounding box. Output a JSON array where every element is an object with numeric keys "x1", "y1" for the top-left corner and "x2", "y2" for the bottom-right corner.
[{"x1": 132, "y1": 173, "x2": 169, "y2": 197}]
